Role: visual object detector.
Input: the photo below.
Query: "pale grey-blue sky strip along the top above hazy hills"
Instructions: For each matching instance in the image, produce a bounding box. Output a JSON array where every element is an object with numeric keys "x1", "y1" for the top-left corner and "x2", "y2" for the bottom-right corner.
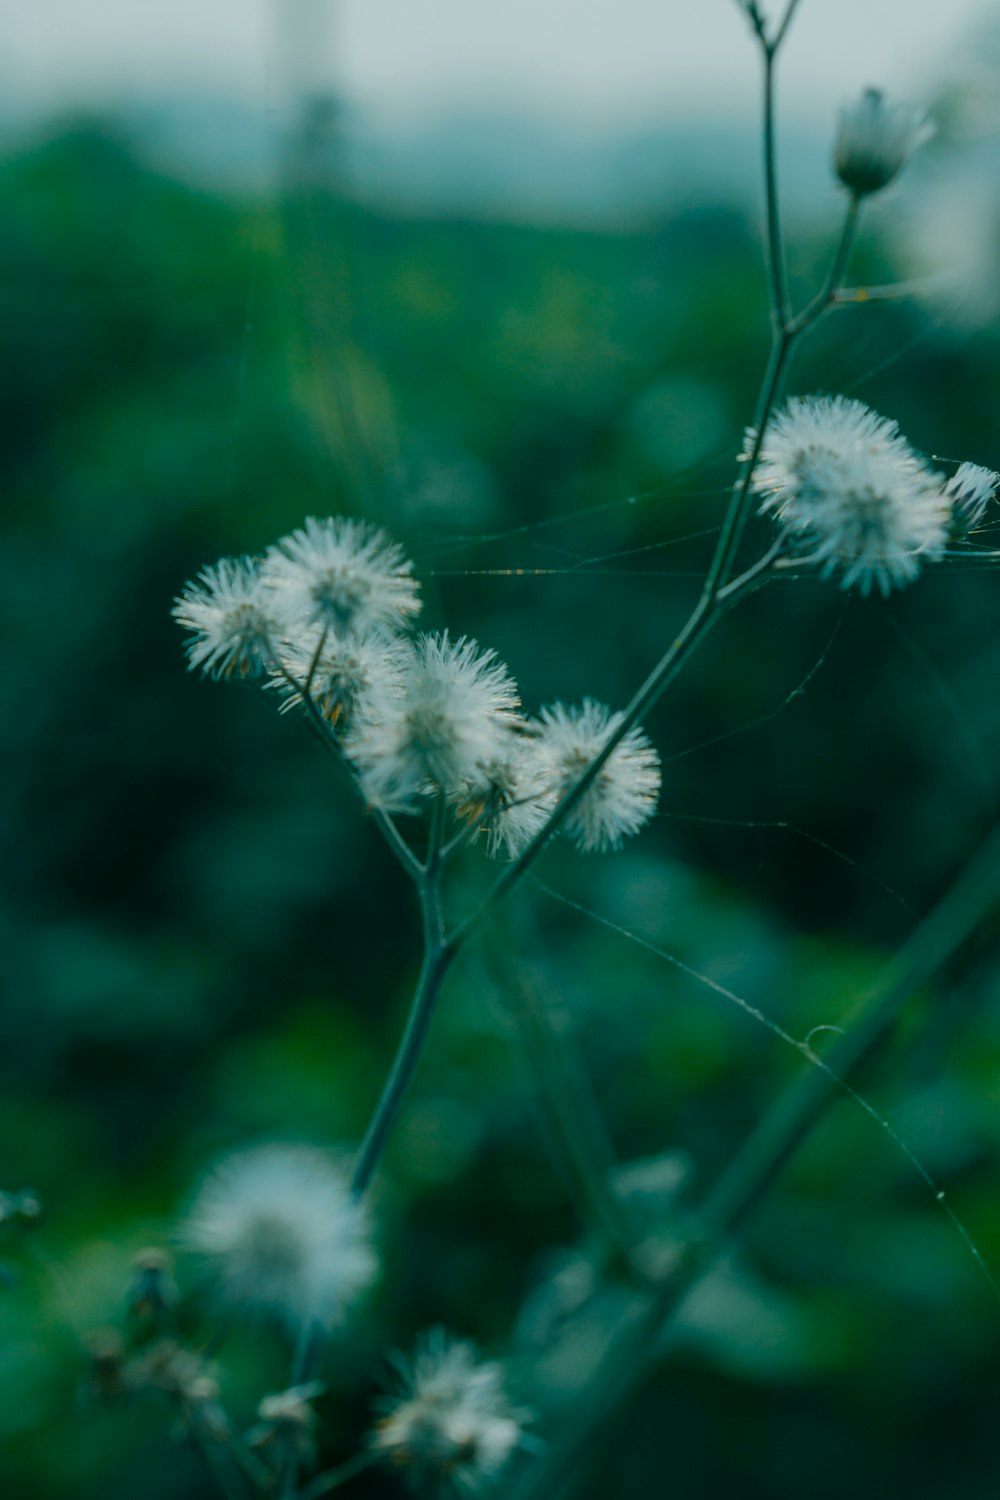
[{"x1": 0, "y1": 0, "x2": 1000, "y2": 128}]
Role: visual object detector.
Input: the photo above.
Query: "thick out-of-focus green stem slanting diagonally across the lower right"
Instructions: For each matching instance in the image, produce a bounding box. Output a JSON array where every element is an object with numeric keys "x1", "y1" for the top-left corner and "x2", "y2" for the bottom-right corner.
[{"x1": 511, "y1": 825, "x2": 1000, "y2": 1500}]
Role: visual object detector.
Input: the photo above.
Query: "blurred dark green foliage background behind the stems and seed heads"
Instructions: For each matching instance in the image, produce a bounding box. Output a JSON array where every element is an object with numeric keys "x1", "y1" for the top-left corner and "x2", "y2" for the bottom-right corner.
[{"x1": 0, "y1": 67, "x2": 1000, "y2": 1500}]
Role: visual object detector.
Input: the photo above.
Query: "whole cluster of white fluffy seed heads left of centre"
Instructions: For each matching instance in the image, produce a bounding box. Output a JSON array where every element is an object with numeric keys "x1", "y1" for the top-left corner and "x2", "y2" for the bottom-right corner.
[{"x1": 174, "y1": 518, "x2": 660, "y2": 858}]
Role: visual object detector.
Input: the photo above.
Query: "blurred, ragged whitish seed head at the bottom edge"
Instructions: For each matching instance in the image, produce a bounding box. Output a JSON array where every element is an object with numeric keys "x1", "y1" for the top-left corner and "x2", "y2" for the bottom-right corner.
[{"x1": 370, "y1": 1329, "x2": 528, "y2": 1491}]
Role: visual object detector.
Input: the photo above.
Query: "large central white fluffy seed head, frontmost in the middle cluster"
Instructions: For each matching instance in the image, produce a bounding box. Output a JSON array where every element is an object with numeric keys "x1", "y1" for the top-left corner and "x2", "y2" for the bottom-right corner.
[{"x1": 348, "y1": 633, "x2": 517, "y2": 812}]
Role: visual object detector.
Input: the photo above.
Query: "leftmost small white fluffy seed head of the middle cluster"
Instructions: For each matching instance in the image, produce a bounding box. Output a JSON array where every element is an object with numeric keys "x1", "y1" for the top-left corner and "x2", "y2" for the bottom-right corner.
[{"x1": 174, "y1": 558, "x2": 279, "y2": 678}]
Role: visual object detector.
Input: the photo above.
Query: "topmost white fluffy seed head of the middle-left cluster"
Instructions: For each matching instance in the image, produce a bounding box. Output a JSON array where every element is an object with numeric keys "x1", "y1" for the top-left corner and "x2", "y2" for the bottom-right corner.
[{"x1": 264, "y1": 516, "x2": 420, "y2": 633}]
